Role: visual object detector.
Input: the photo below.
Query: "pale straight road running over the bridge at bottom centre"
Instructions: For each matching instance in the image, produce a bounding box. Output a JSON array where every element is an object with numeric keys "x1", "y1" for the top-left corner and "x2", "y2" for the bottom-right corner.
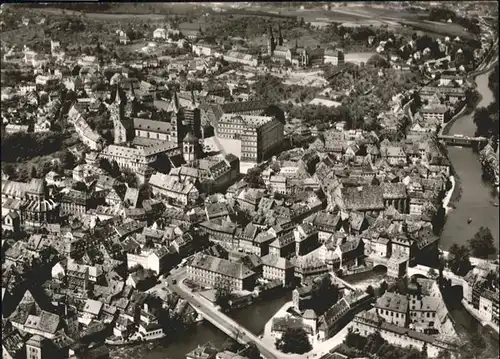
[{"x1": 166, "y1": 268, "x2": 303, "y2": 359}]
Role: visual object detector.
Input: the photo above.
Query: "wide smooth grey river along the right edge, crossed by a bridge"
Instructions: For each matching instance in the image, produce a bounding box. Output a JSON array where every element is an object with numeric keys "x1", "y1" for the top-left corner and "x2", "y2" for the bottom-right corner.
[{"x1": 441, "y1": 71, "x2": 499, "y2": 250}]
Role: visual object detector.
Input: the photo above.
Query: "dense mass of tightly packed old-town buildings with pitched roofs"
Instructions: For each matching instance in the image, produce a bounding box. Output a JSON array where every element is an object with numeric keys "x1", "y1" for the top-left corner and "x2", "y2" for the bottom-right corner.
[{"x1": 1, "y1": 5, "x2": 498, "y2": 359}]
